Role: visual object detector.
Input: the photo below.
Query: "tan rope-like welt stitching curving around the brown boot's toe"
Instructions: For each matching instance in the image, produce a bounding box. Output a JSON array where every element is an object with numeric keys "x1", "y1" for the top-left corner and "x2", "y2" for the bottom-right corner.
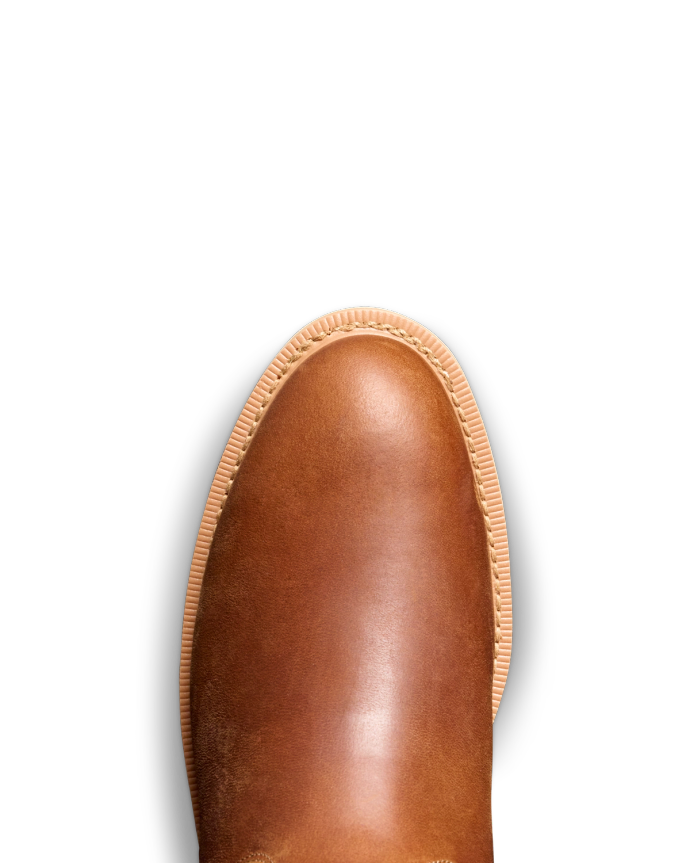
[{"x1": 214, "y1": 321, "x2": 501, "y2": 664}]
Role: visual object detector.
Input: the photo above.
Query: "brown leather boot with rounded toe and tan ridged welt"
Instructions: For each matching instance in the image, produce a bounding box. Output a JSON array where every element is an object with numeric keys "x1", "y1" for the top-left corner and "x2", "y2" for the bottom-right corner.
[{"x1": 180, "y1": 308, "x2": 511, "y2": 863}]
